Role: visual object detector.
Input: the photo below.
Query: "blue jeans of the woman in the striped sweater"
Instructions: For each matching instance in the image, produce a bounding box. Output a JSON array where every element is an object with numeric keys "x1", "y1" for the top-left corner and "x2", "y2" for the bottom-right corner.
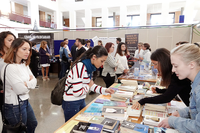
[{"x1": 62, "y1": 99, "x2": 86, "y2": 122}]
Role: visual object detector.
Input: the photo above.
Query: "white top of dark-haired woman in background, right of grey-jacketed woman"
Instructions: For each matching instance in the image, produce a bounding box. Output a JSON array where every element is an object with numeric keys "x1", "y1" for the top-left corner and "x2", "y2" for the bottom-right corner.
[{"x1": 115, "y1": 53, "x2": 129, "y2": 74}]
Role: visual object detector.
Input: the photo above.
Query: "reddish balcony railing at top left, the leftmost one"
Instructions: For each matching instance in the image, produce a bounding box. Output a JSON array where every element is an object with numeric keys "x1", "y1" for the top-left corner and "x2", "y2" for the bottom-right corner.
[{"x1": 9, "y1": 12, "x2": 31, "y2": 24}]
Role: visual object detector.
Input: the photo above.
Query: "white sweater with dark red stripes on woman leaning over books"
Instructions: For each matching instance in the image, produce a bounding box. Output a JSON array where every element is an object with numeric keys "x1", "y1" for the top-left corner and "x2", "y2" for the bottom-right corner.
[{"x1": 63, "y1": 62, "x2": 107, "y2": 101}]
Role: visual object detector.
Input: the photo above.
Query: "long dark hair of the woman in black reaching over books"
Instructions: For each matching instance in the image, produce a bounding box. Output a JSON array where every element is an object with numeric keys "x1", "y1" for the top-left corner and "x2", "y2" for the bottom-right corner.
[{"x1": 151, "y1": 48, "x2": 172, "y2": 87}]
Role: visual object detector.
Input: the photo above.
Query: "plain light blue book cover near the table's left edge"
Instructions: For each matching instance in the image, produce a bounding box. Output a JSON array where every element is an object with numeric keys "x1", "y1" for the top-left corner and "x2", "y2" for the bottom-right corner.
[{"x1": 84, "y1": 103, "x2": 103, "y2": 113}]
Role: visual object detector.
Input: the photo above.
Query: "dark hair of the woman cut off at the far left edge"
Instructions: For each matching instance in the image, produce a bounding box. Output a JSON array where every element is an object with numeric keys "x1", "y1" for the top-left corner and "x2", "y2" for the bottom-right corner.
[{"x1": 0, "y1": 31, "x2": 16, "y2": 56}]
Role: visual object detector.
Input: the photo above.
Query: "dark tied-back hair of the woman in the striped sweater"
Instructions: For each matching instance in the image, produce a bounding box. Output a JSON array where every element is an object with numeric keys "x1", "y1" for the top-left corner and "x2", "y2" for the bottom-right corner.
[{"x1": 73, "y1": 45, "x2": 108, "y2": 65}]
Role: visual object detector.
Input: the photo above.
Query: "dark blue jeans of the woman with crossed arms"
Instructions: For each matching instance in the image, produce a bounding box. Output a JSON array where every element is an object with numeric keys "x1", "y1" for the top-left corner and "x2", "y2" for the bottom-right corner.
[{"x1": 5, "y1": 100, "x2": 37, "y2": 133}]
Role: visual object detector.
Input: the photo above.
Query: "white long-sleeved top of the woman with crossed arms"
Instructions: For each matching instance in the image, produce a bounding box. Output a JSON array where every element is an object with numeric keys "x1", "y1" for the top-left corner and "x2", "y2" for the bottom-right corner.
[{"x1": 1, "y1": 63, "x2": 37, "y2": 105}]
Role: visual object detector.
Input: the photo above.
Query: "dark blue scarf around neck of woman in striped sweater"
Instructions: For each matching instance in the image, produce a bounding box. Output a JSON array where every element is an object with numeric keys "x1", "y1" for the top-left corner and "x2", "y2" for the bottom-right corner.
[{"x1": 82, "y1": 59, "x2": 96, "y2": 79}]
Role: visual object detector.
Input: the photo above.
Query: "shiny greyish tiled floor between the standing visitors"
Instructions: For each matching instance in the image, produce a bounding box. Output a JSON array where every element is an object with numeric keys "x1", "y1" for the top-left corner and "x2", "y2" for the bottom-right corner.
[{"x1": 0, "y1": 75, "x2": 105, "y2": 133}]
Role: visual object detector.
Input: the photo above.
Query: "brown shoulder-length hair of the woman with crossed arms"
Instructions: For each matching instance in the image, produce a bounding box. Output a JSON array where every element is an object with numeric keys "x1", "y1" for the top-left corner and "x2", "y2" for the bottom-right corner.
[{"x1": 4, "y1": 38, "x2": 32, "y2": 65}]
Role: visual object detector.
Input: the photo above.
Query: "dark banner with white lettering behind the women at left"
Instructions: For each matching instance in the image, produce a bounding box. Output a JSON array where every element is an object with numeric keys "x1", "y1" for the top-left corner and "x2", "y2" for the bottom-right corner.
[{"x1": 18, "y1": 33, "x2": 54, "y2": 56}]
